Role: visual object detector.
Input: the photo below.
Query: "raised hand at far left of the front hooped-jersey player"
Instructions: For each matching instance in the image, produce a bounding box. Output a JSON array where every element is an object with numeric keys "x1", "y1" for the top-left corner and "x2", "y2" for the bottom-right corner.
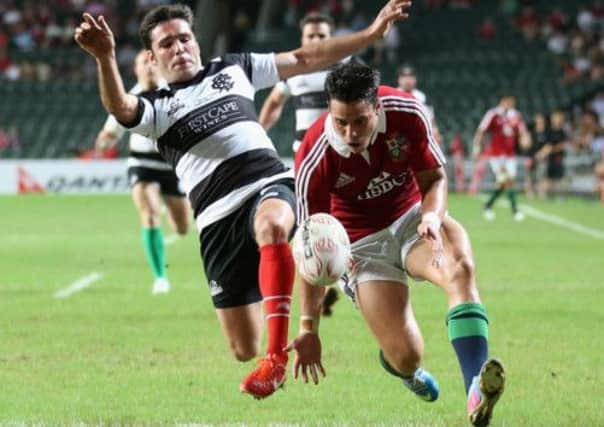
[{"x1": 74, "y1": 13, "x2": 115, "y2": 59}]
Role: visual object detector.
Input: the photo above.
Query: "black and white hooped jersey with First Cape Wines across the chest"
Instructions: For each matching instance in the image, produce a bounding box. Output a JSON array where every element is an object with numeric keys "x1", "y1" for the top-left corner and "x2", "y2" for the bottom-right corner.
[{"x1": 123, "y1": 53, "x2": 293, "y2": 231}]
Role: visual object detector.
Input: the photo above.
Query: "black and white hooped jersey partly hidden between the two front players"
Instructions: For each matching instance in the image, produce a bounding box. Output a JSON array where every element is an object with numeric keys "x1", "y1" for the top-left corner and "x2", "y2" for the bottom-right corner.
[{"x1": 276, "y1": 56, "x2": 360, "y2": 141}]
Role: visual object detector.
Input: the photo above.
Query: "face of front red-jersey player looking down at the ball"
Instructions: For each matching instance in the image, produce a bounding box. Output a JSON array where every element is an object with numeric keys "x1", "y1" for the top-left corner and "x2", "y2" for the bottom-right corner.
[{"x1": 329, "y1": 99, "x2": 378, "y2": 153}]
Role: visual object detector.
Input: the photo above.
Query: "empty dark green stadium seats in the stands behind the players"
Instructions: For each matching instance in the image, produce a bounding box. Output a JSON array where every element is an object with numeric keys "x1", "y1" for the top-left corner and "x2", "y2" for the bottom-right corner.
[{"x1": 0, "y1": 0, "x2": 601, "y2": 158}]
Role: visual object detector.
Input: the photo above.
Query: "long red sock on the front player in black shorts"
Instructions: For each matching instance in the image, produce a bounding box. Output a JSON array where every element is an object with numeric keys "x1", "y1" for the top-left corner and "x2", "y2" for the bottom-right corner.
[{"x1": 258, "y1": 242, "x2": 295, "y2": 354}]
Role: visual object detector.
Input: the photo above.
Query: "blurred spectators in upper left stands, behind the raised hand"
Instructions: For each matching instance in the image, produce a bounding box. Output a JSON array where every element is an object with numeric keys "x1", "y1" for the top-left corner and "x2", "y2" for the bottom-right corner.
[{"x1": 0, "y1": 0, "x2": 195, "y2": 81}]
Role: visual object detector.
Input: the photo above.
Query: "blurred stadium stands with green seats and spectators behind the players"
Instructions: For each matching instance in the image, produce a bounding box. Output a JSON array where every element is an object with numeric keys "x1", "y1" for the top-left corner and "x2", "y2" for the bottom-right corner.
[{"x1": 0, "y1": 0, "x2": 604, "y2": 195}]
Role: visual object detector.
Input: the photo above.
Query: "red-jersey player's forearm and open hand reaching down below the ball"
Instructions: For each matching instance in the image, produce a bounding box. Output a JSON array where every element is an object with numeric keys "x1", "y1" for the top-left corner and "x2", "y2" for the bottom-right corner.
[{"x1": 285, "y1": 277, "x2": 326, "y2": 384}]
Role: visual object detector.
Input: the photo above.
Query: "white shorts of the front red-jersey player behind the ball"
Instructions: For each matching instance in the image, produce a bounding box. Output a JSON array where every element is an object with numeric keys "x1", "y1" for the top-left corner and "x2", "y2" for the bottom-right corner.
[{"x1": 339, "y1": 203, "x2": 421, "y2": 300}]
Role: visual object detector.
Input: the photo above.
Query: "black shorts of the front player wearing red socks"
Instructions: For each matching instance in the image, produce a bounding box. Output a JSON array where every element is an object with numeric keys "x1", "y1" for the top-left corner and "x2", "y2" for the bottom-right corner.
[{"x1": 199, "y1": 179, "x2": 296, "y2": 308}]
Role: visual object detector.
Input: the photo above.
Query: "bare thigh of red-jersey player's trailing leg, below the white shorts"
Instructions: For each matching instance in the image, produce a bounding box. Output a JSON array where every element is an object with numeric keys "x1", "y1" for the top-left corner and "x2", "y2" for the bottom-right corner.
[{"x1": 356, "y1": 280, "x2": 423, "y2": 353}]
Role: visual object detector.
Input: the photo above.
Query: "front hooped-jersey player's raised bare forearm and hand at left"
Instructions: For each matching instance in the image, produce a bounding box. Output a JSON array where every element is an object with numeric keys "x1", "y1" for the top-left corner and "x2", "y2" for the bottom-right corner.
[{"x1": 74, "y1": 13, "x2": 138, "y2": 123}]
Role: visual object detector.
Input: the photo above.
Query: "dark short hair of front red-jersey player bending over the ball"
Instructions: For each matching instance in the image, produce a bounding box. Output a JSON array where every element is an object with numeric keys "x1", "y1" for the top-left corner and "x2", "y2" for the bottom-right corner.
[{"x1": 325, "y1": 62, "x2": 380, "y2": 104}]
